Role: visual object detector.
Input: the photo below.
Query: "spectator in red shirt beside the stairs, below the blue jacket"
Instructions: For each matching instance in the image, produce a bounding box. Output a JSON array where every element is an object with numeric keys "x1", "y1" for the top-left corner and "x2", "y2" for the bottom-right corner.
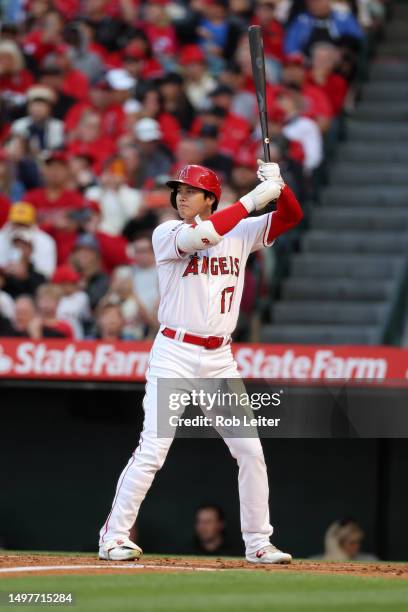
[{"x1": 306, "y1": 42, "x2": 348, "y2": 117}]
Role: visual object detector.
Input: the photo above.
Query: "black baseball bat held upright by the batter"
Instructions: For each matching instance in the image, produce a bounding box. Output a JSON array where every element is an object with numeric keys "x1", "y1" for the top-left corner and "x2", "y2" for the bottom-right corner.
[{"x1": 248, "y1": 26, "x2": 271, "y2": 162}]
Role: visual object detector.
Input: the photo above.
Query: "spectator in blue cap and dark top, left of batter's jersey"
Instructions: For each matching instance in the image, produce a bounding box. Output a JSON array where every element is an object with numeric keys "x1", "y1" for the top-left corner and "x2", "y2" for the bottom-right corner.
[{"x1": 70, "y1": 234, "x2": 109, "y2": 310}]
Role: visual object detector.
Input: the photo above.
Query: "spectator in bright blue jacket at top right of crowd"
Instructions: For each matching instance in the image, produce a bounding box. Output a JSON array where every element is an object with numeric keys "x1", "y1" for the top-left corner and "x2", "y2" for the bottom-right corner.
[{"x1": 285, "y1": 0, "x2": 363, "y2": 55}]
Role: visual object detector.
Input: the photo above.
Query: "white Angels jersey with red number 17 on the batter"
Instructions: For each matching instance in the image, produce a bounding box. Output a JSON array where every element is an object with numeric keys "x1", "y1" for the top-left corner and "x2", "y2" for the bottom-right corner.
[{"x1": 153, "y1": 213, "x2": 273, "y2": 336}]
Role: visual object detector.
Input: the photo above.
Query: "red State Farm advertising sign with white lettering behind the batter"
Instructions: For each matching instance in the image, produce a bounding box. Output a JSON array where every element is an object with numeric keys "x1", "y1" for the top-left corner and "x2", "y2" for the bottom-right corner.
[{"x1": 0, "y1": 339, "x2": 408, "y2": 385}]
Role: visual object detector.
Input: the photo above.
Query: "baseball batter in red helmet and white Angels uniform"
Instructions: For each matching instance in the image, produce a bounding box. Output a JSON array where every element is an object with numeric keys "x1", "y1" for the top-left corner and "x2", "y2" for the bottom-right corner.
[{"x1": 99, "y1": 160, "x2": 302, "y2": 563}]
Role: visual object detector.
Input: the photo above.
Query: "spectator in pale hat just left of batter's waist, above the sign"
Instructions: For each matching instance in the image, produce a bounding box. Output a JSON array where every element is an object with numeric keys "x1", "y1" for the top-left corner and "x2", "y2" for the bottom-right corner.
[{"x1": 103, "y1": 266, "x2": 158, "y2": 340}]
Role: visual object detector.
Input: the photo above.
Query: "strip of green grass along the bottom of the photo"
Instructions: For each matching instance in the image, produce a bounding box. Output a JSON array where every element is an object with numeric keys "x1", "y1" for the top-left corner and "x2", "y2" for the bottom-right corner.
[{"x1": 0, "y1": 570, "x2": 408, "y2": 612}]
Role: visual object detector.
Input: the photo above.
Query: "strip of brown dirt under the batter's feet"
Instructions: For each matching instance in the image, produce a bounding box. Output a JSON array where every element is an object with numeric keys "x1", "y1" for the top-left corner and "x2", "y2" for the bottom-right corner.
[{"x1": 0, "y1": 553, "x2": 408, "y2": 580}]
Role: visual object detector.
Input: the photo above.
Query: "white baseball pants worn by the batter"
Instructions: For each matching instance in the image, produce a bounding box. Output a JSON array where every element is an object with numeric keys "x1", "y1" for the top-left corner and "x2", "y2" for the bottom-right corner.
[{"x1": 99, "y1": 332, "x2": 273, "y2": 554}]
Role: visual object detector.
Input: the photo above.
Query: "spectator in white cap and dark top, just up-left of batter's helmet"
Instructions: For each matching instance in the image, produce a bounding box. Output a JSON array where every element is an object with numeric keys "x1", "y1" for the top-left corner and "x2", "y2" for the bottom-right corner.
[{"x1": 134, "y1": 117, "x2": 171, "y2": 184}]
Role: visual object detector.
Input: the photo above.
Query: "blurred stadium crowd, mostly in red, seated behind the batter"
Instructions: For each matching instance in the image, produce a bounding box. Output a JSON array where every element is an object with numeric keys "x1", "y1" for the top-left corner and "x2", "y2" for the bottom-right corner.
[{"x1": 0, "y1": 0, "x2": 386, "y2": 340}]
